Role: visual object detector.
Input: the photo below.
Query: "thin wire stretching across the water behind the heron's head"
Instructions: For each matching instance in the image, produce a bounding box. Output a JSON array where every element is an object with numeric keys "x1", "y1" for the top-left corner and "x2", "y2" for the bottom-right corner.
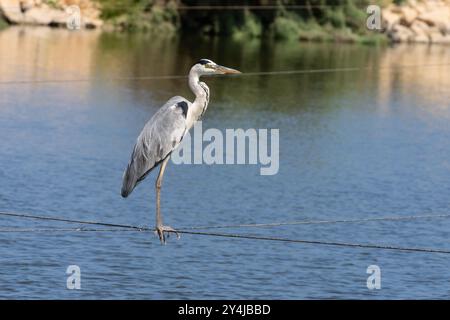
[{"x1": 0, "y1": 63, "x2": 450, "y2": 85}]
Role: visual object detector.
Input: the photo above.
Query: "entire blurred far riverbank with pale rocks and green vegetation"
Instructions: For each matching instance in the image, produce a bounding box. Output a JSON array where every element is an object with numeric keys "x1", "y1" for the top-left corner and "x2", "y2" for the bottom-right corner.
[{"x1": 0, "y1": 0, "x2": 450, "y2": 44}]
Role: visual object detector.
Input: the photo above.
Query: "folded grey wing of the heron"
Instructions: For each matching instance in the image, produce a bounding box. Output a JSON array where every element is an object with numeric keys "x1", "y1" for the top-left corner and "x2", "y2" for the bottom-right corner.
[{"x1": 122, "y1": 96, "x2": 191, "y2": 197}]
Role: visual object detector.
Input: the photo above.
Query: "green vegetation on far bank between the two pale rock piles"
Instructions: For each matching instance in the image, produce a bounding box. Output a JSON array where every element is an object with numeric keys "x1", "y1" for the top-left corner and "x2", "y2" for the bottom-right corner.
[{"x1": 97, "y1": 0, "x2": 390, "y2": 42}]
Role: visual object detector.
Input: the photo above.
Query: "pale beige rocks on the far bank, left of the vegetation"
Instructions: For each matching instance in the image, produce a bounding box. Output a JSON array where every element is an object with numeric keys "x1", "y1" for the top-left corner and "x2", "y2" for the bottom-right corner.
[{"x1": 0, "y1": 0, "x2": 103, "y2": 28}]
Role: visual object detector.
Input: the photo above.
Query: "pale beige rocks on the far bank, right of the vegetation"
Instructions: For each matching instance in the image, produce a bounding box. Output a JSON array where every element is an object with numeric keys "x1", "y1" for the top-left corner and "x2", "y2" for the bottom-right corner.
[{"x1": 382, "y1": 0, "x2": 450, "y2": 44}]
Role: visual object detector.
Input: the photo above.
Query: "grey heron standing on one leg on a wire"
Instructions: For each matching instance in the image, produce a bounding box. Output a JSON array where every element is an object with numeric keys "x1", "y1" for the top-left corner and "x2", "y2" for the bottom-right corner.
[{"x1": 122, "y1": 59, "x2": 240, "y2": 244}]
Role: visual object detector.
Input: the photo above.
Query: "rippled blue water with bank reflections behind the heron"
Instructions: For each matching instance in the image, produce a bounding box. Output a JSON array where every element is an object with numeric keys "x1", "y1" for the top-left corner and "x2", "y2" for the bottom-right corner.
[{"x1": 0, "y1": 28, "x2": 450, "y2": 299}]
